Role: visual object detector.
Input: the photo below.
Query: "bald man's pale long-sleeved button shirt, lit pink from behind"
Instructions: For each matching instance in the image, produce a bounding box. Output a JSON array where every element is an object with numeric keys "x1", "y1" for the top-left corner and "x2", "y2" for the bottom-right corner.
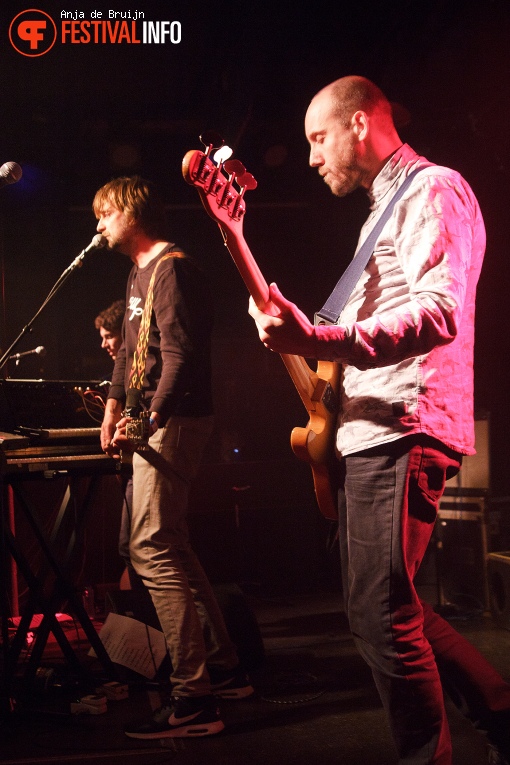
[{"x1": 316, "y1": 145, "x2": 485, "y2": 455}]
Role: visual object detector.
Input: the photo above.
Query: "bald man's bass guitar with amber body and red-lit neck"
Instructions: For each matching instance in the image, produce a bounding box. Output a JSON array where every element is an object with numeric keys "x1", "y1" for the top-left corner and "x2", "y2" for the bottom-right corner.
[{"x1": 182, "y1": 146, "x2": 341, "y2": 520}]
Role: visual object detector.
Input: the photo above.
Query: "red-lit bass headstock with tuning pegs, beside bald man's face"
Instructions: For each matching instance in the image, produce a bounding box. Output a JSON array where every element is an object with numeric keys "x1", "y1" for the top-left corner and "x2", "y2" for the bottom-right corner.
[{"x1": 182, "y1": 131, "x2": 257, "y2": 232}]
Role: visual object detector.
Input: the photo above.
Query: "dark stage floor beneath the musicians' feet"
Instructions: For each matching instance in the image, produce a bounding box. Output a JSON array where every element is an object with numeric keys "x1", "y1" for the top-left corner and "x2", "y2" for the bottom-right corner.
[{"x1": 0, "y1": 592, "x2": 510, "y2": 765}]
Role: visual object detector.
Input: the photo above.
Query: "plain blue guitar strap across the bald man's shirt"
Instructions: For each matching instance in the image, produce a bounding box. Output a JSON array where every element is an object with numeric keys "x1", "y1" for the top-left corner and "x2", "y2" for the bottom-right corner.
[{"x1": 314, "y1": 165, "x2": 428, "y2": 325}]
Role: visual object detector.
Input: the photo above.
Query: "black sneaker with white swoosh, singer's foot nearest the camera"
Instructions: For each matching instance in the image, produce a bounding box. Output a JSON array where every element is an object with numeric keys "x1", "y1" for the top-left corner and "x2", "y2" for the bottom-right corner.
[{"x1": 124, "y1": 696, "x2": 225, "y2": 738}]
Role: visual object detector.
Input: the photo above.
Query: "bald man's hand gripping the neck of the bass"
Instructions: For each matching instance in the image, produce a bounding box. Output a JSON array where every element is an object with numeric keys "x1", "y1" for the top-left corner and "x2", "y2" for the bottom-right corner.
[{"x1": 249, "y1": 284, "x2": 316, "y2": 359}]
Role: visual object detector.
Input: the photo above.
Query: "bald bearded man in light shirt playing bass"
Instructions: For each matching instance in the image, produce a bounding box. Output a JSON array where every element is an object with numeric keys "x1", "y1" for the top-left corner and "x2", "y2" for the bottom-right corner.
[{"x1": 250, "y1": 76, "x2": 510, "y2": 765}]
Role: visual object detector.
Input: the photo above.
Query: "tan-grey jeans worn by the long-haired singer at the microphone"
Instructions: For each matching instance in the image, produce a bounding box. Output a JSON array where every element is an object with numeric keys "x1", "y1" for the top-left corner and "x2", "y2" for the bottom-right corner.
[{"x1": 129, "y1": 417, "x2": 238, "y2": 696}]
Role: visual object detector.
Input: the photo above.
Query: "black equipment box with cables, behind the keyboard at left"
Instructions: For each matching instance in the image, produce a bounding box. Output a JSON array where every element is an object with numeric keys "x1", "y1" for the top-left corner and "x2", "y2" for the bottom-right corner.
[{"x1": 0, "y1": 379, "x2": 102, "y2": 433}]
